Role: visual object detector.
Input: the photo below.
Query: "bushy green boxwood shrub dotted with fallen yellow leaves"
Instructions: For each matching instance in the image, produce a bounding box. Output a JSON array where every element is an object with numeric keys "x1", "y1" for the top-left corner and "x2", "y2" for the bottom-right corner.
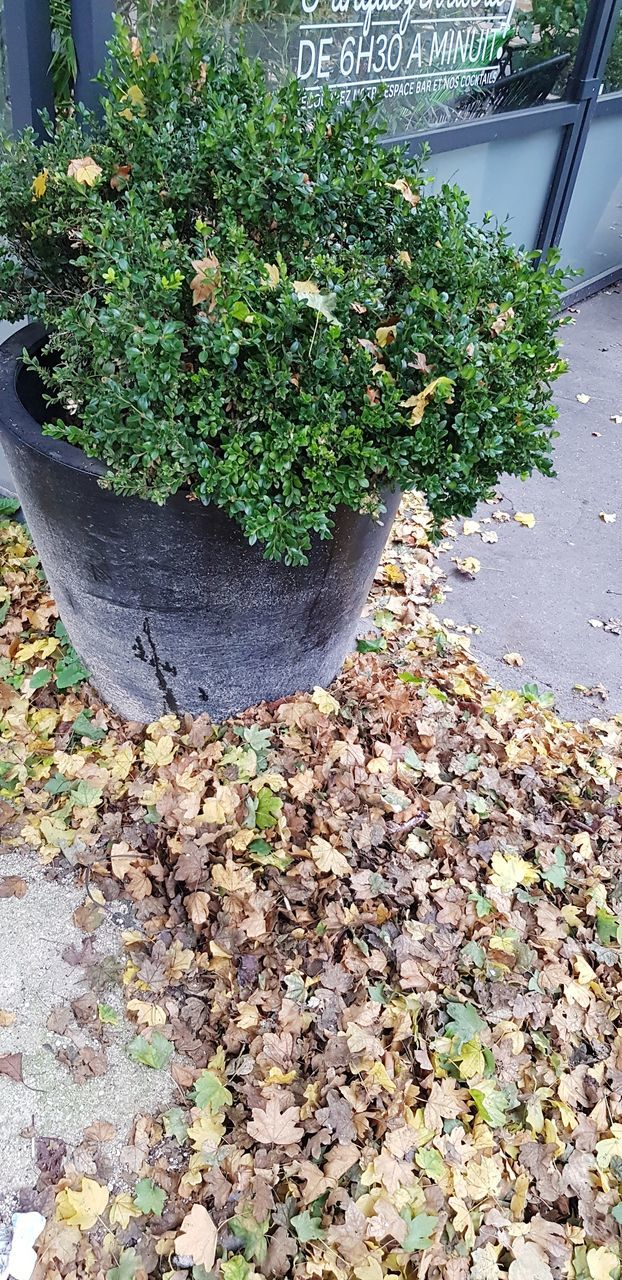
[{"x1": 0, "y1": 0, "x2": 563, "y2": 563}]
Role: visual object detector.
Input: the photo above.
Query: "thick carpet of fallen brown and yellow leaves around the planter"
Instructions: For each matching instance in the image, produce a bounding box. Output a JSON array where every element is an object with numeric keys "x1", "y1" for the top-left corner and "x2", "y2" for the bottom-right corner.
[{"x1": 0, "y1": 499, "x2": 622, "y2": 1280}]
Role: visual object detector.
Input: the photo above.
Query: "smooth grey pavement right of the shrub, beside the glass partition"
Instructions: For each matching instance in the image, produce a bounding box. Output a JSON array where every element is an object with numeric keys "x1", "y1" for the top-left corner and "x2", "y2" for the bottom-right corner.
[{"x1": 439, "y1": 285, "x2": 622, "y2": 719}]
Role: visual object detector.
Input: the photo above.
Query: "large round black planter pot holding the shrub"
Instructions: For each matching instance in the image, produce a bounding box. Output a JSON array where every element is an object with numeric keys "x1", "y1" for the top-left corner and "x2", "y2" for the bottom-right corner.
[{"x1": 0, "y1": 325, "x2": 398, "y2": 722}]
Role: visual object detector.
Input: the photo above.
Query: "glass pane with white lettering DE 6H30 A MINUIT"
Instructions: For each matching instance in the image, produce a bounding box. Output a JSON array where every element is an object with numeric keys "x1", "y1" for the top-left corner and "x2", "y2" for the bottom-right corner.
[{"x1": 119, "y1": 0, "x2": 587, "y2": 137}]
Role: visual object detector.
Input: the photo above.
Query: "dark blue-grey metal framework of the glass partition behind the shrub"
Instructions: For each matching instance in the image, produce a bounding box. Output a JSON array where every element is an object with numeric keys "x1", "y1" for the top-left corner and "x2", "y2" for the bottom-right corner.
[{"x1": 4, "y1": 0, "x2": 622, "y2": 297}]
